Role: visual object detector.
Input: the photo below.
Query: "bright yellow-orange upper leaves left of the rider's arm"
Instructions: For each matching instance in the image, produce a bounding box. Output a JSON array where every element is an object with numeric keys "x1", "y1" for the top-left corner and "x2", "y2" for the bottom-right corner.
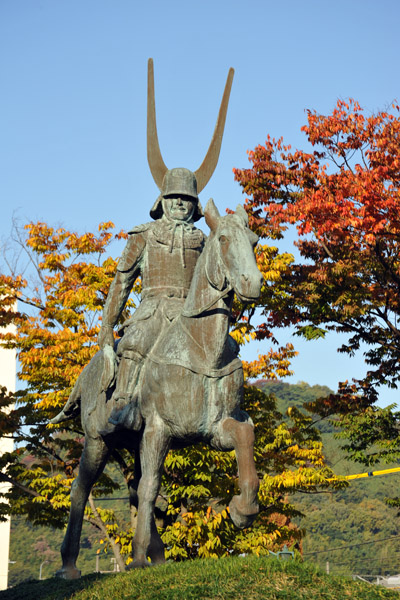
[{"x1": 0, "y1": 222, "x2": 126, "y2": 410}]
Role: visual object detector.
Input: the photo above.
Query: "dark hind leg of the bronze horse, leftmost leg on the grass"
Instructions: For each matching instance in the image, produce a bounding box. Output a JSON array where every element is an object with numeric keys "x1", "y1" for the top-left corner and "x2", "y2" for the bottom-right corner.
[{"x1": 56, "y1": 436, "x2": 109, "y2": 579}]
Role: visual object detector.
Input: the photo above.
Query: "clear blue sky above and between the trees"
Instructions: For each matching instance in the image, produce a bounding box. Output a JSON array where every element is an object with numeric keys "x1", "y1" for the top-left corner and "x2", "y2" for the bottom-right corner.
[{"x1": 0, "y1": 0, "x2": 400, "y2": 403}]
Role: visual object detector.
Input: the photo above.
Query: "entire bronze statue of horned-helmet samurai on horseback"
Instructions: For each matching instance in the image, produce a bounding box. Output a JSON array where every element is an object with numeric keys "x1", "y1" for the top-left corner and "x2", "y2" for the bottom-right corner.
[{"x1": 53, "y1": 60, "x2": 263, "y2": 578}]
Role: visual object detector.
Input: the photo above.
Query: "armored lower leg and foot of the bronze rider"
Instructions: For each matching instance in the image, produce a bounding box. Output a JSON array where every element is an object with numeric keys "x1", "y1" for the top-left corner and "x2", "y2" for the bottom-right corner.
[{"x1": 108, "y1": 351, "x2": 142, "y2": 431}]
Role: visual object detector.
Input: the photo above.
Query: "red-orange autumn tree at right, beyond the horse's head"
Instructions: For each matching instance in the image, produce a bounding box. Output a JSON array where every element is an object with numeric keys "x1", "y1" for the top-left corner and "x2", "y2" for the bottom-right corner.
[{"x1": 234, "y1": 100, "x2": 400, "y2": 478}]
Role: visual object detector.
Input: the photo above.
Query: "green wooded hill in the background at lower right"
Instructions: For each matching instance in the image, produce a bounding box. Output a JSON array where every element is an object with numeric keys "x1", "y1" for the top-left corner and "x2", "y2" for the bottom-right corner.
[{"x1": 256, "y1": 380, "x2": 400, "y2": 575}]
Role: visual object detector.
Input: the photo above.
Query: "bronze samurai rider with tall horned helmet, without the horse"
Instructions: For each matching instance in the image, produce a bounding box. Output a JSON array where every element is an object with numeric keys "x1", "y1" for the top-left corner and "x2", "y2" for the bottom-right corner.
[{"x1": 99, "y1": 59, "x2": 233, "y2": 433}]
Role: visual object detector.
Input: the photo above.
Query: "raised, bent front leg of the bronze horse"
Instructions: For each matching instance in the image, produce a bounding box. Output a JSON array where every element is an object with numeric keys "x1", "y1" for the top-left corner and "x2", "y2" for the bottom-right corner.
[{"x1": 215, "y1": 417, "x2": 260, "y2": 529}]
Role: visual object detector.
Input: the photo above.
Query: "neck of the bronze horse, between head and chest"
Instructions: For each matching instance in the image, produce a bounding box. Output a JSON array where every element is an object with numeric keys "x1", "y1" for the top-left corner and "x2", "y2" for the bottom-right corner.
[{"x1": 181, "y1": 244, "x2": 233, "y2": 368}]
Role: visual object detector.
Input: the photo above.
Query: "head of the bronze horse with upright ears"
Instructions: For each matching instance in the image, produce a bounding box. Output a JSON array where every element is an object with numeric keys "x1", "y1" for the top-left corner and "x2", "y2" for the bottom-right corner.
[{"x1": 204, "y1": 200, "x2": 264, "y2": 302}]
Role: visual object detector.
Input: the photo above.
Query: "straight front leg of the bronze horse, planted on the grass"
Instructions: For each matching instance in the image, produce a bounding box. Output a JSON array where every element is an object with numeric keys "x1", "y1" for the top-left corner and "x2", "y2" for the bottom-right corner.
[{"x1": 131, "y1": 420, "x2": 170, "y2": 568}]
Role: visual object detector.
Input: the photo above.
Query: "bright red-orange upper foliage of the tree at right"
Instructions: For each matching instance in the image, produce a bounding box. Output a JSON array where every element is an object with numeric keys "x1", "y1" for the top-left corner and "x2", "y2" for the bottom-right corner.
[{"x1": 234, "y1": 100, "x2": 400, "y2": 248}]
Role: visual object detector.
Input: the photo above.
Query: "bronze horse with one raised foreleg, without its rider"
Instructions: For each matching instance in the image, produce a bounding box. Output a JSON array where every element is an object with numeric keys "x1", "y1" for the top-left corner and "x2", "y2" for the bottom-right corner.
[{"x1": 53, "y1": 200, "x2": 263, "y2": 578}]
